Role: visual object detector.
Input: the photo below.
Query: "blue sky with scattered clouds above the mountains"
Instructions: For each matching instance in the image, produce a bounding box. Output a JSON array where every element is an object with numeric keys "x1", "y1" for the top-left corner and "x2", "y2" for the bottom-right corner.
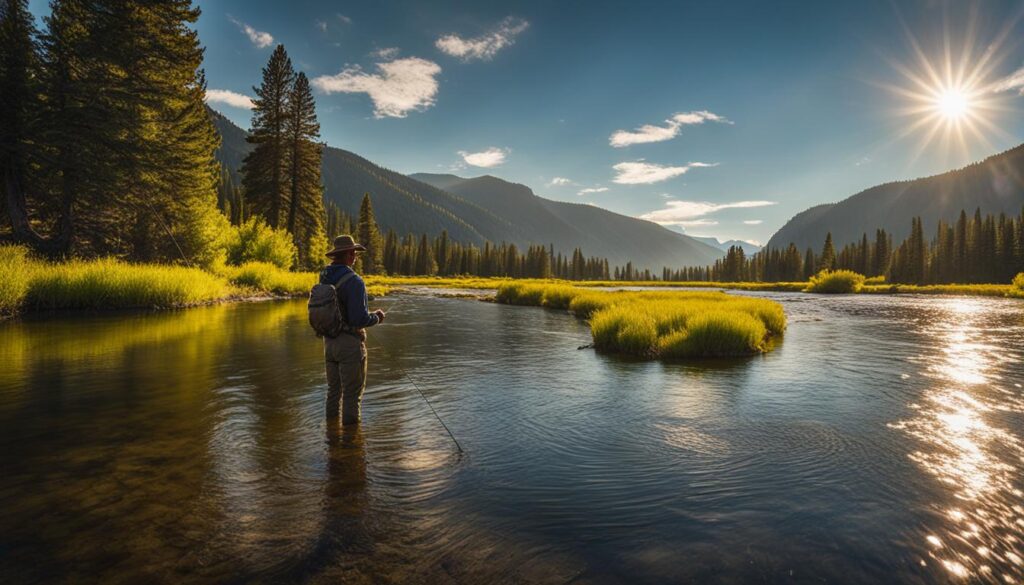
[{"x1": 32, "y1": 0, "x2": 1024, "y2": 242}]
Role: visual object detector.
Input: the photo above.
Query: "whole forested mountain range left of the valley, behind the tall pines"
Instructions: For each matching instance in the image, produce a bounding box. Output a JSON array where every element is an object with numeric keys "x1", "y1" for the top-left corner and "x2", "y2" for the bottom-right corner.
[{"x1": 210, "y1": 110, "x2": 722, "y2": 270}]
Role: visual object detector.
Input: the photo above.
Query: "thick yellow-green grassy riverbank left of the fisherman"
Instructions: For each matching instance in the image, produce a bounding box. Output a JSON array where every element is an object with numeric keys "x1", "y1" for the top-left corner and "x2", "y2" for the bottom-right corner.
[{"x1": 0, "y1": 246, "x2": 389, "y2": 317}]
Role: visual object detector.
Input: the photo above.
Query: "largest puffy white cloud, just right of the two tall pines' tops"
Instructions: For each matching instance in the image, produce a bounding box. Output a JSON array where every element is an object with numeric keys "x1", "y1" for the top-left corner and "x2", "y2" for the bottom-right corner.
[{"x1": 312, "y1": 57, "x2": 441, "y2": 118}]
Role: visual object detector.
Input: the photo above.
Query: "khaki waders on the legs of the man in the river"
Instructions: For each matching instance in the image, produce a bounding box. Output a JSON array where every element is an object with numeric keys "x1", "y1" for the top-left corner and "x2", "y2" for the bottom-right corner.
[{"x1": 324, "y1": 331, "x2": 367, "y2": 424}]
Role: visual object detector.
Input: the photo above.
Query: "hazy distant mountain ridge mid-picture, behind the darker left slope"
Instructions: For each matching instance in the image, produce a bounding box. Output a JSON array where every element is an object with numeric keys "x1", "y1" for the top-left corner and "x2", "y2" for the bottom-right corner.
[{"x1": 410, "y1": 173, "x2": 722, "y2": 270}]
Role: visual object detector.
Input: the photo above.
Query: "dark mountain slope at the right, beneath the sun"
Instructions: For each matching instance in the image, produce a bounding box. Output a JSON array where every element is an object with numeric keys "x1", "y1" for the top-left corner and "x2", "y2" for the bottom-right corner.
[{"x1": 767, "y1": 144, "x2": 1024, "y2": 250}]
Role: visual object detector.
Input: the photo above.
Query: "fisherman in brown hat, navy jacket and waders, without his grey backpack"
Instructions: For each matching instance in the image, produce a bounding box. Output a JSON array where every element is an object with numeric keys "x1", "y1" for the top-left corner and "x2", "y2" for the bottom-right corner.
[{"x1": 310, "y1": 236, "x2": 384, "y2": 425}]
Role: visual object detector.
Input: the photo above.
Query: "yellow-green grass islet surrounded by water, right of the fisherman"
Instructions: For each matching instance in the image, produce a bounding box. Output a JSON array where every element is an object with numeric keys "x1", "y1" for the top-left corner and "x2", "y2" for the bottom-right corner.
[{"x1": 496, "y1": 282, "x2": 785, "y2": 360}]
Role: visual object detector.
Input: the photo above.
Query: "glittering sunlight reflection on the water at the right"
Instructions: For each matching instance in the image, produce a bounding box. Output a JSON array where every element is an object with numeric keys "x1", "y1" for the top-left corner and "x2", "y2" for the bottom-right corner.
[{"x1": 892, "y1": 299, "x2": 1024, "y2": 583}]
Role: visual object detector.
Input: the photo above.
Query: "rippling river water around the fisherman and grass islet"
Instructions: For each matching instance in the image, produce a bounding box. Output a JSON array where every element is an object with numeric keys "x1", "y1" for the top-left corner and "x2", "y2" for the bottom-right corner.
[{"x1": 0, "y1": 294, "x2": 1024, "y2": 583}]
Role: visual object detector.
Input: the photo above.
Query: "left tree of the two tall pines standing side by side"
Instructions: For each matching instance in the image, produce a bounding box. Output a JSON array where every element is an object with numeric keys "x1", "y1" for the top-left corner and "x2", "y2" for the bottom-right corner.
[{"x1": 242, "y1": 45, "x2": 295, "y2": 227}]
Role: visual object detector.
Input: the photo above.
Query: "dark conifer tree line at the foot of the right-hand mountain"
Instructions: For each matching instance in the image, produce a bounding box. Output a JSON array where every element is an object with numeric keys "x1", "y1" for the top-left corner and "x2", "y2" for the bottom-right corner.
[{"x1": 662, "y1": 209, "x2": 1024, "y2": 285}]
